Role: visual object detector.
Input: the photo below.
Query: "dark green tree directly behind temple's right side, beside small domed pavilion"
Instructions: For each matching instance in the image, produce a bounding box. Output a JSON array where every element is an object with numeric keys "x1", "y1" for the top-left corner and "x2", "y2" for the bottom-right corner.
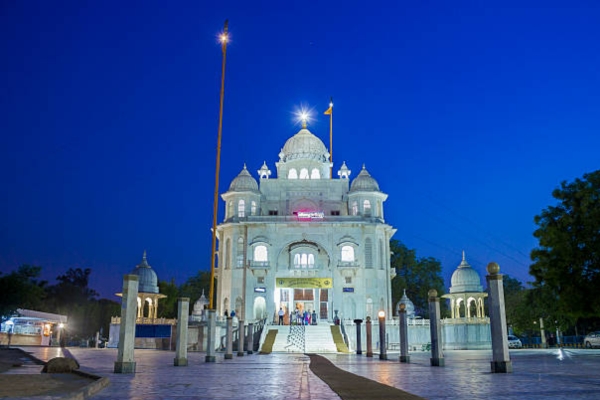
[{"x1": 390, "y1": 240, "x2": 444, "y2": 318}]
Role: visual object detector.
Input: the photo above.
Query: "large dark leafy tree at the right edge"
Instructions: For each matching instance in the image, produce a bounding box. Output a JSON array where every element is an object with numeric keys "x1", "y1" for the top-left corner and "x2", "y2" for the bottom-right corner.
[{"x1": 529, "y1": 170, "x2": 600, "y2": 328}]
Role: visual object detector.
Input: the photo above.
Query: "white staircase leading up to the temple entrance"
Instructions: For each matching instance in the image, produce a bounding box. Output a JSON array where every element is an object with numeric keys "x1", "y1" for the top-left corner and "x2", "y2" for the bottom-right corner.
[{"x1": 261, "y1": 324, "x2": 338, "y2": 353}]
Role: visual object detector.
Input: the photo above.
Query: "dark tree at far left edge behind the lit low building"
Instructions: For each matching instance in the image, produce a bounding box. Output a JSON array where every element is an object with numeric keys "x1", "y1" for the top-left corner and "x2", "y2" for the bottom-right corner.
[{"x1": 0, "y1": 265, "x2": 46, "y2": 318}]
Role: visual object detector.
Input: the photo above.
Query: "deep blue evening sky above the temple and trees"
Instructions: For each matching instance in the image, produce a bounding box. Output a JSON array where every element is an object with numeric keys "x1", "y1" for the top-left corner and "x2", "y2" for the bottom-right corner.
[{"x1": 0, "y1": 0, "x2": 600, "y2": 300}]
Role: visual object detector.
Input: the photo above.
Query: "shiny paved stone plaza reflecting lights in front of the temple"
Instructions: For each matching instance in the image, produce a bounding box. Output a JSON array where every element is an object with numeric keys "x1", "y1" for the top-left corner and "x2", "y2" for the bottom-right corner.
[{"x1": 14, "y1": 348, "x2": 600, "y2": 400}]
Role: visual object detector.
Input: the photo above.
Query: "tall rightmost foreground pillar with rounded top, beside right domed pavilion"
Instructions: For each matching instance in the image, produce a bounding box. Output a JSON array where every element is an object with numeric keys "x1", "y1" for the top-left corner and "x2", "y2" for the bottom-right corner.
[{"x1": 486, "y1": 262, "x2": 513, "y2": 373}]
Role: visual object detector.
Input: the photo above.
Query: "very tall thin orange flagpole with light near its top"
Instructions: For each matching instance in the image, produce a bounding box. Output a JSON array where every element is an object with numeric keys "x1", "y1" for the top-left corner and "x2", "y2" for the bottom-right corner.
[{"x1": 208, "y1": 20, "x2": 229, "y2": 310}]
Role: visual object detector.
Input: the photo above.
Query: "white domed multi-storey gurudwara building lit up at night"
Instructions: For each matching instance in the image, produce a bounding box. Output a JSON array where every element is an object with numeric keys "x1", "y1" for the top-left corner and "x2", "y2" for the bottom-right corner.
[{"x1": 216, "y1": 124, "x2": 395, "y2": 324}]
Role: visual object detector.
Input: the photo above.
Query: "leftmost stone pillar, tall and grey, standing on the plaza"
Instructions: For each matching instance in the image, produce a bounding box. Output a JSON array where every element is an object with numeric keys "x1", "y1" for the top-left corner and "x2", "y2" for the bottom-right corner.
[{"x1": 114, "y1": 274, "x2": 139, "y2": 374}]
